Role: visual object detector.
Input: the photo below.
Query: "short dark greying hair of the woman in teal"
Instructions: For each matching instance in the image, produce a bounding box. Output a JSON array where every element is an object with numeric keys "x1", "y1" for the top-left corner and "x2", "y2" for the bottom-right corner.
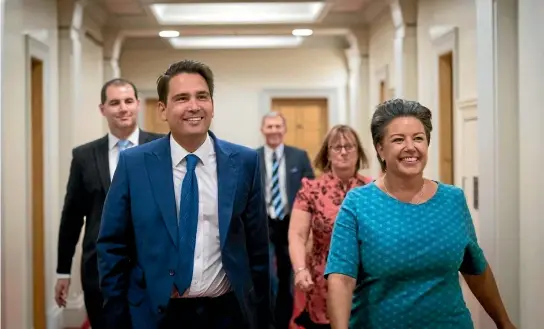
[{"x1": 370, "y1": 98, "x2": 433, "y2": 171}]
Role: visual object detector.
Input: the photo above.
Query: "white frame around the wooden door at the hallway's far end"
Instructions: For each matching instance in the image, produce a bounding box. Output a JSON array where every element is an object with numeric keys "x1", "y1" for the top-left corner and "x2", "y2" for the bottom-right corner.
[{"x1": 259, "y1": 88, "x2": 340, "y2": 143}]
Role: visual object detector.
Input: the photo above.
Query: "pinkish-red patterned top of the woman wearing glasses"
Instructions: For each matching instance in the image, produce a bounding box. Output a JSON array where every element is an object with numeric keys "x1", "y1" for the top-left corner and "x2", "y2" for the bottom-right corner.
[{"x1": 293, "y1": 173, "x2": 372, "y2": 324}]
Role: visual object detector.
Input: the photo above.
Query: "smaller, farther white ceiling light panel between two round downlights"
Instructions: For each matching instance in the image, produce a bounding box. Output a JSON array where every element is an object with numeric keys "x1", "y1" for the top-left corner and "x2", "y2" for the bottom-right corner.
[{"x1": 168, "y1": 35, "x2": 302, "y2": 49}]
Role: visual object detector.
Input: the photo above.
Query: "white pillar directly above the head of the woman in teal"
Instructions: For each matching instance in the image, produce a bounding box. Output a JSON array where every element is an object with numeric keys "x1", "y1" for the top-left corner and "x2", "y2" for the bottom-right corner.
[{"x1": 390, "y1": 0, "x2": 418, "y2": 100}]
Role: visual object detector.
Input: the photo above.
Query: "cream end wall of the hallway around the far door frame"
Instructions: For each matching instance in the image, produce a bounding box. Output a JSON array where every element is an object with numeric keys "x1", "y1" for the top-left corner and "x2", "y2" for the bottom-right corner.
[{"x1": 120, "y1": 49, "x2": 347, "y2": 147}]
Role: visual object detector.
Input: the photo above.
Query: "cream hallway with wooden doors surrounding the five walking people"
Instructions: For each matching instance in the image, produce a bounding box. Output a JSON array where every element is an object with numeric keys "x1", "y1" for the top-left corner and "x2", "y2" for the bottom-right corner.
[{"x1": 0, "y1": 0, "x2": 544, "y2": 329}]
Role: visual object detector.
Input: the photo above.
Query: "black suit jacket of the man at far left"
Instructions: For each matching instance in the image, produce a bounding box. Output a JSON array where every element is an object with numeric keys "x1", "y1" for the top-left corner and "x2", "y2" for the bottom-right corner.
[{"x1": 57, "y1": 130, "x2": 162, "y2": 290}]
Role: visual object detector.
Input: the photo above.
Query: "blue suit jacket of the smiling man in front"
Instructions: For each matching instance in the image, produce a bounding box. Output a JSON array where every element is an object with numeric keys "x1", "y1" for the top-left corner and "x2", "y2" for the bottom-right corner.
[{"x1": 96, "y1": 132, "x2": 272, "y2": 329}]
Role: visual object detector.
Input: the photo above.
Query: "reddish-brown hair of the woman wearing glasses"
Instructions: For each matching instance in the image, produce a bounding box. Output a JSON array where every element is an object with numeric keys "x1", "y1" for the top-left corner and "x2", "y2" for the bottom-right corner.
[{"x1": 314, "y1": 125, "x2": 368, "y2": 172}]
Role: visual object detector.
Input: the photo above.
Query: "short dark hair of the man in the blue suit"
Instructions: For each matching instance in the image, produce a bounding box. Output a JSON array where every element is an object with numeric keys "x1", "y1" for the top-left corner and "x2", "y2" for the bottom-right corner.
[{"x1": 157, "y1": 59, "x2": 214, "y2": 104}]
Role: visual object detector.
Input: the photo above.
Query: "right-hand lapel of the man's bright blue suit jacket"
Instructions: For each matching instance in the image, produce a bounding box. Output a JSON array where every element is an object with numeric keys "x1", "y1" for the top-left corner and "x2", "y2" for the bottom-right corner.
[{"x1": 210, "y1": 132, "x2": 238, "y2": 248}]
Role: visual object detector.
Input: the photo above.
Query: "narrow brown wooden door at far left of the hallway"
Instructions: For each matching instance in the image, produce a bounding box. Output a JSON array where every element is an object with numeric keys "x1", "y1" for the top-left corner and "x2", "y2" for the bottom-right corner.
[{"x1": 29, "y1": 58, "x2": 46, "y2": 329}]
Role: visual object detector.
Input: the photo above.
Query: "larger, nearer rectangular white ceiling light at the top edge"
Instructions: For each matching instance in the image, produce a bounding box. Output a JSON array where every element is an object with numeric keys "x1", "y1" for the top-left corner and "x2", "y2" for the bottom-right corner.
[{"x1": 150, "y1": 1, "x2": 325, "y2": 25}]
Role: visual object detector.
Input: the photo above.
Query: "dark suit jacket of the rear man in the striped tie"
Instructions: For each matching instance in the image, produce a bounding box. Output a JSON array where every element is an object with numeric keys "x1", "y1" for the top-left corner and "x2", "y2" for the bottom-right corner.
[{"x1": 257, "y1": 145, "x2": 315, "y2": 214}]
